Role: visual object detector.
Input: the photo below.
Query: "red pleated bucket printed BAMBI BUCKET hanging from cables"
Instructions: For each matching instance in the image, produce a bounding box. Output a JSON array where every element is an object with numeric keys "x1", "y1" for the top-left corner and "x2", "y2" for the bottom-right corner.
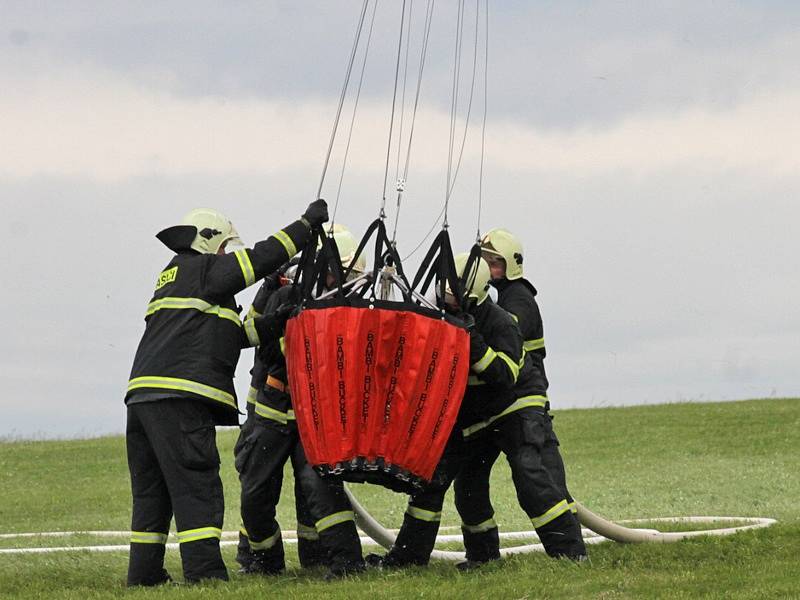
[{"x1": 286, "y1": 303, "x2": 469, "y2": 491}]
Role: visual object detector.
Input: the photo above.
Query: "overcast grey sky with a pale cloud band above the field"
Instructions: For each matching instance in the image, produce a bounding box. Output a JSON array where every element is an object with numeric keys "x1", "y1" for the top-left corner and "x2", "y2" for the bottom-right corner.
[{"x1": 0, "y1": 0, "x2": 800, "y2": 437}]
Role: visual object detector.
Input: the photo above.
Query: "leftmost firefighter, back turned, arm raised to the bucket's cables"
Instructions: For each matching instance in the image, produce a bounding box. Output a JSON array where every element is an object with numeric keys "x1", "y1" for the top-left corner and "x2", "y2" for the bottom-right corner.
[{"x1": 125, "y1": 200, "x2": 328, "y2": 586}]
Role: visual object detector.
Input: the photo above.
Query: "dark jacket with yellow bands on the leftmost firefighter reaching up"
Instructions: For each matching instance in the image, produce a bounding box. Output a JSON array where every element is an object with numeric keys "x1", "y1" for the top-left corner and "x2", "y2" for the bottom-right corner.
[{"x1": 125, "y1": 220, "x2": 310, "y2": 425}]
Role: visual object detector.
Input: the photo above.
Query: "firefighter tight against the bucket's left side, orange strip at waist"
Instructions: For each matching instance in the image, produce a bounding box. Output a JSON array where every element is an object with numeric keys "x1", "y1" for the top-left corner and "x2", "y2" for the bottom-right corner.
[{"x1": 236, "y1": 224, "x2": 365, "y2": 579}]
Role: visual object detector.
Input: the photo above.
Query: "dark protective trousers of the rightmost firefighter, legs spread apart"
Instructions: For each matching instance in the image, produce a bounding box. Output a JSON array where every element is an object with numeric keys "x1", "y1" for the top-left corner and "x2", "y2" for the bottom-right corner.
[{"x1": 455, "y1": 408, "x2": 586, "y2": 562}]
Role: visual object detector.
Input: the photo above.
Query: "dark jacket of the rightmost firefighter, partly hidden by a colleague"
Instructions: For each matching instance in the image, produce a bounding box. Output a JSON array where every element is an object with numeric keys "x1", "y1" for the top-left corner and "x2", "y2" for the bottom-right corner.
[{"x1": 492, "y1": 279, "x2": 548, "y2": 396}]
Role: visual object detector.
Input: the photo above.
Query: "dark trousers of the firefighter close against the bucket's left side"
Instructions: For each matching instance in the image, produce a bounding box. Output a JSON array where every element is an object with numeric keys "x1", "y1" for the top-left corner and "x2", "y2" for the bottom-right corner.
[{"x1": 236, "y1": 422, "x2": 362, "y2": 571}]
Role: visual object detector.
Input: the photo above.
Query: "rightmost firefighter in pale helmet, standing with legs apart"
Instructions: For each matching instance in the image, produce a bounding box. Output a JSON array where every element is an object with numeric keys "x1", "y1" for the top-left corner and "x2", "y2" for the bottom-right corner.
[{"x1": 454, "y1": 229, "x2": 586, "y2": 569}]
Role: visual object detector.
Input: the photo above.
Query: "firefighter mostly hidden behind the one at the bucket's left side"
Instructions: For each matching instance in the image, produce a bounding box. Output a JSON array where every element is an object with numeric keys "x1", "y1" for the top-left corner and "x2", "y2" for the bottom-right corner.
[{"x1": 233, "y1": 258, "x2": 325, "y2": 570}]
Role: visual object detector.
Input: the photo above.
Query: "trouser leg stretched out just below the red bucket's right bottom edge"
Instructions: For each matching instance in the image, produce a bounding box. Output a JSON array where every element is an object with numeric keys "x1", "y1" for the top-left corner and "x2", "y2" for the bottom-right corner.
[{"x1": 385, "y1": 431, "x2": 464, "y2": 566}]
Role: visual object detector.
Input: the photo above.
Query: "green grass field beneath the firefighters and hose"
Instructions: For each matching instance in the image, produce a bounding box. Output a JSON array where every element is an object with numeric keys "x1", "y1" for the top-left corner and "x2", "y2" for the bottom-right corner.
[{"x1": 0, "y1": 399, "x2": 800, "y2": 600}]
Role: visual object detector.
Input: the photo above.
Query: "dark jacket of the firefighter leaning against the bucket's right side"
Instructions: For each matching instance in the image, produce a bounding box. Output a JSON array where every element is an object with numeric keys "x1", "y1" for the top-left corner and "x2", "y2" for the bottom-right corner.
[{"x1": 456, "y1": 298, "x2": 522, "y2": 430}]
